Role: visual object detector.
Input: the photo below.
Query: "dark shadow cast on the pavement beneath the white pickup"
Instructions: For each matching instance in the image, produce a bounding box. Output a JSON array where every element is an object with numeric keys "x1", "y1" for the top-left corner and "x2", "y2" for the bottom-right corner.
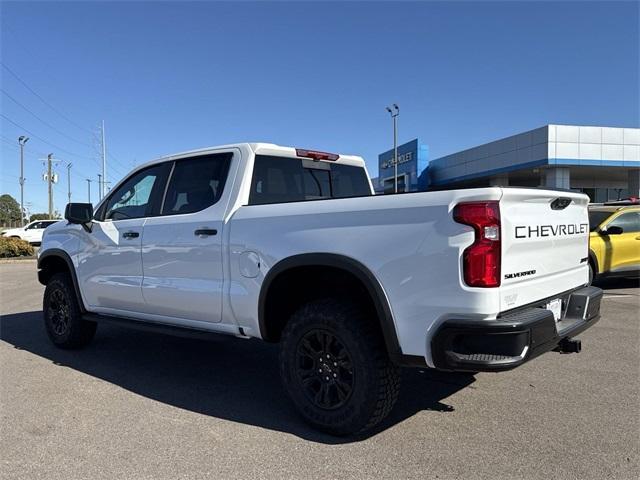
[{"x1": 0, "y1": 311, "x2": 474, "y2": 444}]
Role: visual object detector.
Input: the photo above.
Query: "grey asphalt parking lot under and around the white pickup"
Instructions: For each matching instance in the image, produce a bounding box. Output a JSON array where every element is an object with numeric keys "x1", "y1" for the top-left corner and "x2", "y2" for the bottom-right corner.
[{"x1": 0, "y1": 261, "x2": 640, "y2": 480}]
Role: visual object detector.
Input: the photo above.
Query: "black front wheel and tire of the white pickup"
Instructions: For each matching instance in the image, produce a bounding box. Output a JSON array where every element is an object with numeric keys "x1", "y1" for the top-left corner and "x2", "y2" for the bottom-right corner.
[{"x1": 42, "y1": 272, "x2": 97, "y2": 349}]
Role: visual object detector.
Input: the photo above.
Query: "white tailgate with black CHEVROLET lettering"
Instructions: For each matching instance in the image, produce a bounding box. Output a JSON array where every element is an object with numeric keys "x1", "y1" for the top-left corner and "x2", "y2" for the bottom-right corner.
[{"x1": 500, "y1": 188, "x2": 589, "y2": 311}]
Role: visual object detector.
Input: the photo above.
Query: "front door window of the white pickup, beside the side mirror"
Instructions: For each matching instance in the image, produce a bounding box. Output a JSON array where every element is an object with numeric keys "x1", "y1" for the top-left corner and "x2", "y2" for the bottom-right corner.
[{"x1": 99, "y1": 164, "x2": 168, "y2": 220}]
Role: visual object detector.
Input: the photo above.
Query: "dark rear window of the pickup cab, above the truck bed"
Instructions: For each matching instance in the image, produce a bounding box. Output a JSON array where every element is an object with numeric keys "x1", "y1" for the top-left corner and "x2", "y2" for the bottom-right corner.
[{"x1": 249, "y1": 155, "x2": 371, "y2": 205}]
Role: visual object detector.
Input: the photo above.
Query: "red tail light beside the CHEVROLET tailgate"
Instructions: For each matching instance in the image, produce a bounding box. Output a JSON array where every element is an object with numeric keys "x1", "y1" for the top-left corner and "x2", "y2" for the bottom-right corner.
[{"x1": 453, "y1": 201, "x2": 501, "y2": 288}]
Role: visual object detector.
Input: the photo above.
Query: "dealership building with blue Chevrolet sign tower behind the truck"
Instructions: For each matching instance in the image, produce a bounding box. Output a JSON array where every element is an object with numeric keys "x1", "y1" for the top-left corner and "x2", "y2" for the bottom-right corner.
[{"x1": 374, "y1": 125, "x2": 640, "y2": 202}]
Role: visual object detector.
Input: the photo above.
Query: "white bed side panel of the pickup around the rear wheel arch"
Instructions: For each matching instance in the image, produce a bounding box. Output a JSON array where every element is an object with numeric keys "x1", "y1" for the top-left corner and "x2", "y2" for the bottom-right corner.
[{"x1": 227, "y1": 188, "x2": 501, "y2": 362}]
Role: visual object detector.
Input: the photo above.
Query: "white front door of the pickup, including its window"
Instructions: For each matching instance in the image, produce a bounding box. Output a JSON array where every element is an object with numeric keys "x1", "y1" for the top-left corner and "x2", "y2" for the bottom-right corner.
[{"x1": 77, "y1": 164, "x2": 169, "y2": 314}]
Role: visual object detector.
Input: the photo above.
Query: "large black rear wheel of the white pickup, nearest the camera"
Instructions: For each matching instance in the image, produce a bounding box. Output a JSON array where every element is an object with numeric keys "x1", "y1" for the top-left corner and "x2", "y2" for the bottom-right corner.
[{"x1": 280, "y1": 299, "x2": 400, "y2": 435}]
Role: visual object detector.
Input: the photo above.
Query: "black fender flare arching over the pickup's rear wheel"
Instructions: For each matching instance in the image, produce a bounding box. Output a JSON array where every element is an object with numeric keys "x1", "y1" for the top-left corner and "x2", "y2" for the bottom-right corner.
[{"x1": 258, "y1": 253, "x2": 402, "y2": 360}]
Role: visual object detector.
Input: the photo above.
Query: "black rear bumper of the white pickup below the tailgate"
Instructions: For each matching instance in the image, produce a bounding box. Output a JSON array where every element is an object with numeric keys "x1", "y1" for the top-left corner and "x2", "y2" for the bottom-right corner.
[{"x1": 431, "y1": 287, "x2": 602, "y2": 372}]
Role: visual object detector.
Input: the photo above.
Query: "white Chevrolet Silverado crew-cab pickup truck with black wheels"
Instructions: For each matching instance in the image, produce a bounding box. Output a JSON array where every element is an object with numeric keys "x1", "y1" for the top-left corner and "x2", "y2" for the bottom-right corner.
[{"x1": 38, "y1": 143, "x2": 602, "y2": 435}]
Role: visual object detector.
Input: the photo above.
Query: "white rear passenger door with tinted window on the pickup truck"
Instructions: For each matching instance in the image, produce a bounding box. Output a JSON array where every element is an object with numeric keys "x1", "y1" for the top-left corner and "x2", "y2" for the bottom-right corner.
[{"x1": 142, "y1": 150, "x2": 239, "y2": 322}]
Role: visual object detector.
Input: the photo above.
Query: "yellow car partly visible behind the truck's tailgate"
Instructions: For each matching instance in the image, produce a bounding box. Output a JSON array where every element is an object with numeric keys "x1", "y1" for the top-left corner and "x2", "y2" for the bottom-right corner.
[{"x1": 589, "y1": 202, "x2": 640, "y2": 283}]
